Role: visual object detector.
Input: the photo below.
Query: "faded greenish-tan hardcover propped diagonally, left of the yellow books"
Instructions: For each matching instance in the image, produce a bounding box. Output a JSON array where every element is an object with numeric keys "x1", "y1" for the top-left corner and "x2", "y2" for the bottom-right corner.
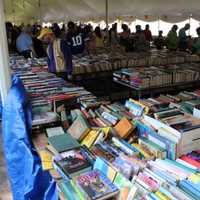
[{"x1": 67, "y1": 115, "x2": 90, "y2": 141}]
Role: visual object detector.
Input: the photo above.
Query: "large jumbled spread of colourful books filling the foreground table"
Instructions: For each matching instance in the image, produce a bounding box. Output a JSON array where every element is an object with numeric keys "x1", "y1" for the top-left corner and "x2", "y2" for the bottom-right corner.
[{"x1": 34, "y1": 90, "x2": 200, "y2": 200}]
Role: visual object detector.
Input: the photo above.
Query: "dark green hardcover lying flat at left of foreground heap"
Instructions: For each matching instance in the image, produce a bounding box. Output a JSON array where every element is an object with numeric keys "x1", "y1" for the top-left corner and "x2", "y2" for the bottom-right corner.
[{"x1": 48, "y1": 134, "x2": 80, "y2": 153}]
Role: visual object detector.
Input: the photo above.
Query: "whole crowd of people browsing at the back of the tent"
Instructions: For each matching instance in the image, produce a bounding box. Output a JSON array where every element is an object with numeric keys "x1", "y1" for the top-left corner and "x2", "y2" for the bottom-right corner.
[{"x1": 6, "y1": 21, "x2": 200, "y2": 79}]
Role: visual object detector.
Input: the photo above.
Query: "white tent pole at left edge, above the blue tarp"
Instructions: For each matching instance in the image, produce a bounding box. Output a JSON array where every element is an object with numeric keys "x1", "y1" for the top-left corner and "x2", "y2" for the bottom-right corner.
[{"x1": 0, "y1": 0, "x2": 11, "y2": 105}]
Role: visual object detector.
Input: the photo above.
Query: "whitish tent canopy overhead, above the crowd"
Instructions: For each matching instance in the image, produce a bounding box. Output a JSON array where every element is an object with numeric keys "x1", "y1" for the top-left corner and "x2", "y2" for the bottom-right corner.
[{"x1": 4, "y1": 0, "x2": 200, "y2": 23}]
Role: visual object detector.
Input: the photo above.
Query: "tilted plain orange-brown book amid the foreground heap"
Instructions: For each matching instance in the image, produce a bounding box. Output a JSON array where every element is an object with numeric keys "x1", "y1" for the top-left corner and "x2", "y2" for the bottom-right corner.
[{"x1": 114, "y1": 117, "x2": 134, "y2": 138}]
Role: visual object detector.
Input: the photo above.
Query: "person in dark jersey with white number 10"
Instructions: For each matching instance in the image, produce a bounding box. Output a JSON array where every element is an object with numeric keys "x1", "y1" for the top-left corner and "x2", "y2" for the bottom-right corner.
[{"x1": 66, "y1": 22, "x2": 89, "y2": 55}]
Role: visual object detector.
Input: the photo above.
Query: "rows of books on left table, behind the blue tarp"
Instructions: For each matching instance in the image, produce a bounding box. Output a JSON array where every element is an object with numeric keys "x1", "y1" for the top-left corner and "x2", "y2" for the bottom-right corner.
[{"x1": 10, "y1": 56, "x2": 98, "y2": 125}]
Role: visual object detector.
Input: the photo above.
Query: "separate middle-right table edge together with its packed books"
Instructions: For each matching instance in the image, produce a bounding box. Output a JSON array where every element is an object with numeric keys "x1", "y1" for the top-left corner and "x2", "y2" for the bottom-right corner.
[{"x1": 113, "y1": 63, "x2": 200, "y2": 98}]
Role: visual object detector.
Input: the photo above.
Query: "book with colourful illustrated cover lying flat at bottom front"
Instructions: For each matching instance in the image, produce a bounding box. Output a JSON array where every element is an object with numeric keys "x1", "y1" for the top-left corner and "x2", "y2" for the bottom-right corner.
[{"x1": 76, "y1": 169, "x2": 119, "y2": 200}]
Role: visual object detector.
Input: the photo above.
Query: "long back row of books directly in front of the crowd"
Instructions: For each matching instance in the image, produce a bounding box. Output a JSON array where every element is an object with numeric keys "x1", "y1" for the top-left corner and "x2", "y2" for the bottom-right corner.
[{"x1": 73, "y1": 47, "x2": 200, "y2": 79}]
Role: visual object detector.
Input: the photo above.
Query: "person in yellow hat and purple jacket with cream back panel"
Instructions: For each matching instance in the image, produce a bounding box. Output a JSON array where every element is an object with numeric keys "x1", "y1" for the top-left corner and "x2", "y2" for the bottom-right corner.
[{"x1": 38, "y1": 28, "x2": 72, "y2": 80}]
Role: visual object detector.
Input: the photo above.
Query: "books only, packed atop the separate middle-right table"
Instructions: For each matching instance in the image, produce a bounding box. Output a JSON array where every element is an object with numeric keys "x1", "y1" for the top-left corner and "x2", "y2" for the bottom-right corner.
[{"x1": 113, "y1": 63, "x2": 200, "y2": 89}]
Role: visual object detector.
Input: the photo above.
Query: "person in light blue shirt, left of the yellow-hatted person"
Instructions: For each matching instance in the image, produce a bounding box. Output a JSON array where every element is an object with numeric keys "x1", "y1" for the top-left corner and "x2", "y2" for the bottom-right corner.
[{"x1": 16, "y1": 26, "x2": 35, "y2": 58}]
